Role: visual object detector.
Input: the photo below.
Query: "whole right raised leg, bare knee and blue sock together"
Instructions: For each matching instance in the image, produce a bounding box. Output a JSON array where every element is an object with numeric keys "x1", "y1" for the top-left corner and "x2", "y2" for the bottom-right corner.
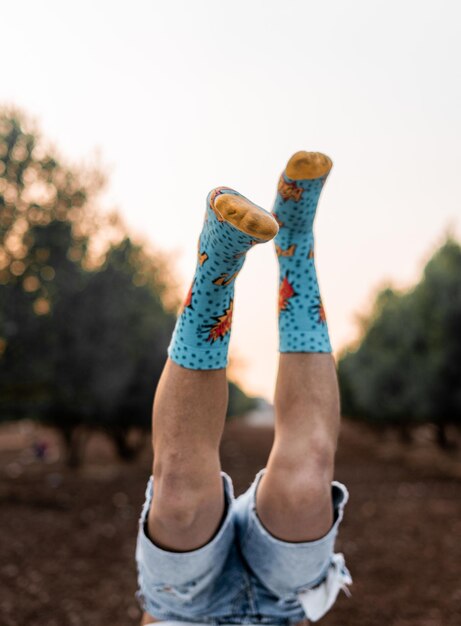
[{"x1": 257, "y1": 153, "x2": 340, "y2": 541}]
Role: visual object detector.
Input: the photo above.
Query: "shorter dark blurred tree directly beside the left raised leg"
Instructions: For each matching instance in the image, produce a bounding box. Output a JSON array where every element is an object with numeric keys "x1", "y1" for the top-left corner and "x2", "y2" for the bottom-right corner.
[{"x1": 60, "y1": 238, "x2": 175, "y2": 459}]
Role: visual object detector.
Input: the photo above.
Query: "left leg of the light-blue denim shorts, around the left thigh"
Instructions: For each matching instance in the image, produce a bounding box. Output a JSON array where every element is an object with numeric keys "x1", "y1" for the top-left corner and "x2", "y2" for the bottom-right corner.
[{"x1": 136, "y1": 472, "x2": 246, "y2": 620}]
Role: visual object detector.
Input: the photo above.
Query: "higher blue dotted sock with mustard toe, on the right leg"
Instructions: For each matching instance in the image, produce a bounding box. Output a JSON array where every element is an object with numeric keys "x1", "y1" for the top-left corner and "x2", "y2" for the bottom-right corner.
[{"x1": 272, "y1": 152, "x2": 332, "y2": 352}]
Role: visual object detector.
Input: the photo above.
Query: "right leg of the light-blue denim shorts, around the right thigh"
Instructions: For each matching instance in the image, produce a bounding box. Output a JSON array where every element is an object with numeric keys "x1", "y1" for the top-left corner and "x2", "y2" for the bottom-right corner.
[{"x1": 235, "y1": 468, "x2": 349, "y2": 605}]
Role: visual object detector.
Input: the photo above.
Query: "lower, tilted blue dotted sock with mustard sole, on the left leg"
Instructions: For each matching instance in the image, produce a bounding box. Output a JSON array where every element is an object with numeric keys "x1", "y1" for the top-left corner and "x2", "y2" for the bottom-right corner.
[{"x1": 168, "y1": 187, "x2": 278, "y2": 370}]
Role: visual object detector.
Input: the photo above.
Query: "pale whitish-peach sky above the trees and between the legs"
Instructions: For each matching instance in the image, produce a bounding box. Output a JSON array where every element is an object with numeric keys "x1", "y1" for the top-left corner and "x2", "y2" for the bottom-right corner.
[{"x1": 0, "y1": 0, "x2": 461, "y2": 400}]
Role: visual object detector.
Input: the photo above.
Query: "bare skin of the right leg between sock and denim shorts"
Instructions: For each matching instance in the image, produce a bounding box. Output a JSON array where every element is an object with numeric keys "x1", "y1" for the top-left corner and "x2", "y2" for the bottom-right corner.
[{"x1": 256, "y1": 353, "x2": 340, "y2": 541}]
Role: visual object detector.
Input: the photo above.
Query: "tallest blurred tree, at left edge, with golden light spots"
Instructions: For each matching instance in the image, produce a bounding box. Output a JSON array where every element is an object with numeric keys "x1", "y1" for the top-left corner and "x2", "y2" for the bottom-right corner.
[{"x1": 0, "y1": 109, "x2": 97, "y2": 444}]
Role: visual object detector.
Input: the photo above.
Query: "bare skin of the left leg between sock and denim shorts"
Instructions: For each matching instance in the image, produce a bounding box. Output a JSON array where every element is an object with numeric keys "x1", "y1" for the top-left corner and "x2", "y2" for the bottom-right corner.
[{"x1": 148, "y1": 358, "x2": 228, "y2": 551}]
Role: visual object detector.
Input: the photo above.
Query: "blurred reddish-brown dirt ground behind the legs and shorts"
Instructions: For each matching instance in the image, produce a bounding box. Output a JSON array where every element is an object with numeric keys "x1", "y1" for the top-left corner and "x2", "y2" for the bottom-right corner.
[{"x1": 0, "y1": 420, "x2": 461, "y2": 626}]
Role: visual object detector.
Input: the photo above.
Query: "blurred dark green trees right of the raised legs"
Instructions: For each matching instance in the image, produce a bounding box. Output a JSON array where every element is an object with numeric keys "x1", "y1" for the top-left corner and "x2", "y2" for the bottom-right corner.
[{"x1": 338, "y1": 236, "x2": 461, "y2": 447}]
